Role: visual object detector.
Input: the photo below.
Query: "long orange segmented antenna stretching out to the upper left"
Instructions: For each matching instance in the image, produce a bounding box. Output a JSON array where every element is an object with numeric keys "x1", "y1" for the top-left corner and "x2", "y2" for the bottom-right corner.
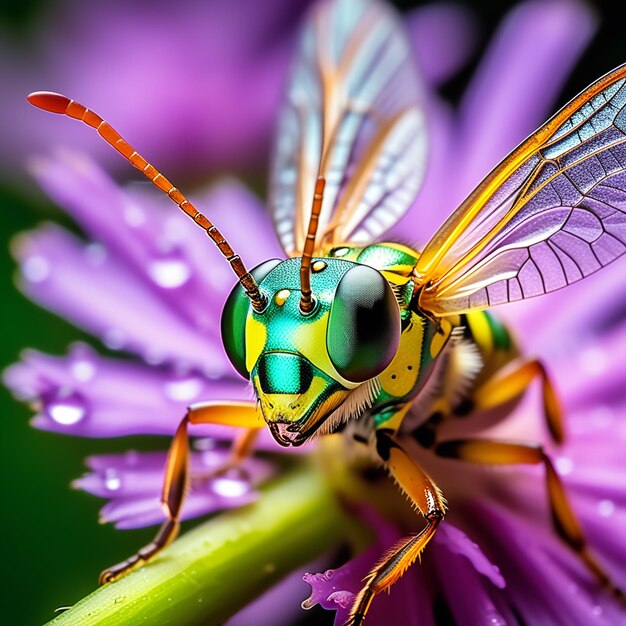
[{"x1": 27, "y1": 91, "x2": 265, "y2": 311}]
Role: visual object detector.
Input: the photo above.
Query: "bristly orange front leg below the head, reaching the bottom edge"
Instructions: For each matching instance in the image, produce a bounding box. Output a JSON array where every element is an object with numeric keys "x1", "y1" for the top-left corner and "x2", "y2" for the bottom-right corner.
[{"x1": 346, "y1": 429, "x2": 446, "y2": 626}]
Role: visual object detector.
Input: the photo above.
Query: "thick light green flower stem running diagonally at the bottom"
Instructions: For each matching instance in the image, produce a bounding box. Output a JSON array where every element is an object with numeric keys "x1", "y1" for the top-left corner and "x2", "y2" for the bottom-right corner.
[{"x1": 50, "y1": 467, "x2": 346, "y2": 626}]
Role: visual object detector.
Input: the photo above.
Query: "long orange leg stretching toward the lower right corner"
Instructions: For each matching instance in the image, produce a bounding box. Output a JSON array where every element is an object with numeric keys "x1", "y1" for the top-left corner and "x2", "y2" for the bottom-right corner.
[{"x1": 435, "y1": 439, "x2": 624, "y2": 598}]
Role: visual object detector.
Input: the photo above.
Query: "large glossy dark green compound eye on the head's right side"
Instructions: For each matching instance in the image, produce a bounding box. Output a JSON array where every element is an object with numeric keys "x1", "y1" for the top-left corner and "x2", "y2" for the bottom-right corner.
[{"x1": 326, "y1": 265, "x2": 401, "y2": 383}]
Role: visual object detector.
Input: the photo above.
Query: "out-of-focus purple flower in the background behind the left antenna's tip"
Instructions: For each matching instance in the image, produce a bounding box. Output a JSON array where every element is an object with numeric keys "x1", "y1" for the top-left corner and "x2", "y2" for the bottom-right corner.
[{"x1": 0, "y1": 0, "x2": 309, "y2": 177}]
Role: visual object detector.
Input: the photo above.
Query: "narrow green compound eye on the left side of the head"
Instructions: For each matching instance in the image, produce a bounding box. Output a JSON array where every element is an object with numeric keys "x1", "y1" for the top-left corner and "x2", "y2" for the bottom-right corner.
[{"x1": 222, "y1": 259, "x2": 281, "y2": 378}]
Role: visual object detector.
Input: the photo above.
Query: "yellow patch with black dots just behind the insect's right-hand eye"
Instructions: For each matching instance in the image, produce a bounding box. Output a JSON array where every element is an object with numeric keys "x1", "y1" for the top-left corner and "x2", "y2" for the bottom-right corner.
[{"x1": 378, "y1": 316, "x2": 424, "y2": 397}]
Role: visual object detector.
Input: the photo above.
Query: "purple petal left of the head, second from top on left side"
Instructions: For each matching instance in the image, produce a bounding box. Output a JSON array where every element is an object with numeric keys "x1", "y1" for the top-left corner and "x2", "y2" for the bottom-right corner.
[{"x1": 14, "y1": 225, "x2": 232, "y2": 376}]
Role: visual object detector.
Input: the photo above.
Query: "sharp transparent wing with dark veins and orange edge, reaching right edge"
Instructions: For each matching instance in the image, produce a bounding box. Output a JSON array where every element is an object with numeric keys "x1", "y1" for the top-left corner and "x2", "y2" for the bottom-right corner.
[{"x1": 415, "y1": 65, "x2": 626, "y2": 315}]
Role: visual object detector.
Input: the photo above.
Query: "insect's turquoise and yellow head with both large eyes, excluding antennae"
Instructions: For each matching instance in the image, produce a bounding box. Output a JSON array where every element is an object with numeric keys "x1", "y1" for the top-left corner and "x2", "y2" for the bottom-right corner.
[{"x1": 222, "y1": 258, "x2": 400, "y2": 445}]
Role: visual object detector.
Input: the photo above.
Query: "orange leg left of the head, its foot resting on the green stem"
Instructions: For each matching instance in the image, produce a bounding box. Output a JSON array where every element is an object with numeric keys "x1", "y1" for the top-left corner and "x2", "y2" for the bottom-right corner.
[{"x1": 99, "y1": 402, "x2": 264, "y2": 585}]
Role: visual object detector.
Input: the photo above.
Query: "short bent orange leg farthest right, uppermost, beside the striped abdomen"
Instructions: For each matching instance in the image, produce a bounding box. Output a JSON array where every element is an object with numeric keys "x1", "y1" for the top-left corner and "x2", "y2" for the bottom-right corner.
[{"x1": 471, "y1": 359, "x2": 565, "y2": 443}]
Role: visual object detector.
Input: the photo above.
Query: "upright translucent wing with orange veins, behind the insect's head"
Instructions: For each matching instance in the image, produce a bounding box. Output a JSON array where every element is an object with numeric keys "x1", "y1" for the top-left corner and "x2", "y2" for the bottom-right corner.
[{"x1": 270, "y1": 0, "x2": 426, "y2": 256}]
